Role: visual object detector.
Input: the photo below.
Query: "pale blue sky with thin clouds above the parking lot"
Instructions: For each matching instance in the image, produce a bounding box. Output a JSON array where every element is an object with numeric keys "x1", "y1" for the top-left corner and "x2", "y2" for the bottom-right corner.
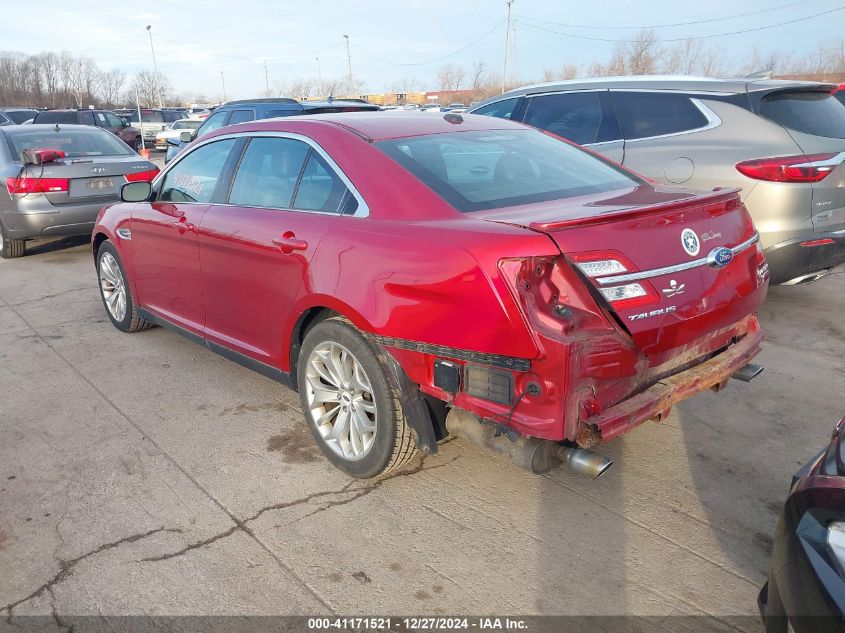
[{"x1": 0, "y1": 0, "x2": 845, "y2": 99}]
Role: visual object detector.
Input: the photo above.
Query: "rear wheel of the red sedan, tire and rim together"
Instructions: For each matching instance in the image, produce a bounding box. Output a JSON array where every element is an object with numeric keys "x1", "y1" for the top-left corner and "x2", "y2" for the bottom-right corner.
[{"x1": 297, "y1": 318, "x2": 417, "y2": 479}]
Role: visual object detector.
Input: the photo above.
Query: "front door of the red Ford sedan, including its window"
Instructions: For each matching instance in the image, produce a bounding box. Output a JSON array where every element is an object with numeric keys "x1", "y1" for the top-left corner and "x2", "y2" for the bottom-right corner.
[{"x1": 130, "y1": 139, "x2": 235, "y2": 334}]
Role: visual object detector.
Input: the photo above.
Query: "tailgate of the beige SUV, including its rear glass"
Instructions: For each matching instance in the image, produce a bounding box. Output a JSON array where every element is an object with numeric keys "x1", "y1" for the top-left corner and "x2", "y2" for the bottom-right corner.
[{"x1": 757, "y1": 89, "x2": 845, "y2": 233}]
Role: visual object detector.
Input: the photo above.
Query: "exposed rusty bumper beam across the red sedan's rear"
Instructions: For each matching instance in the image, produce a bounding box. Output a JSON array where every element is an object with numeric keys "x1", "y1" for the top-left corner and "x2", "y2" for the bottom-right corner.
[{"x1": 580, "y1": 329, "x2": 763, "y2": 444}]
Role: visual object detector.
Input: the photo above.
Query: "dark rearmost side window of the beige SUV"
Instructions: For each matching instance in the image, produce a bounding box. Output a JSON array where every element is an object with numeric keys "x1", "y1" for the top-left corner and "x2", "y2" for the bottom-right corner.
[{"x1": 613, "y1": 92, "x2": 708, "y2": 140}]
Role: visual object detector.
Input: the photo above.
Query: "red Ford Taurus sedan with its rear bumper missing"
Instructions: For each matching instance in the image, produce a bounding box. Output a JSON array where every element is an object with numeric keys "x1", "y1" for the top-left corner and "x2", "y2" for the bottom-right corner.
[{"x1": 93, "y1": 113, "x2": 768, "y2": 477}]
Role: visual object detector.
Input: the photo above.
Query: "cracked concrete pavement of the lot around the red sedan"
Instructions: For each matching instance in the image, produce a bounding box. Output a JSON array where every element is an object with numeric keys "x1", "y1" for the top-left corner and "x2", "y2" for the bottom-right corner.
[{"x1": 0, "y1": 233, "x2": 845, "y2": 627}]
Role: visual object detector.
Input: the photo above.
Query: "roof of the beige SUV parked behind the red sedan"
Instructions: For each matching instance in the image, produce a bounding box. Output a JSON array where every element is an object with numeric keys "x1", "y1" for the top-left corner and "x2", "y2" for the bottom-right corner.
[{"x1": 483, "y1": 75, "x2": 833, "y2": 103}]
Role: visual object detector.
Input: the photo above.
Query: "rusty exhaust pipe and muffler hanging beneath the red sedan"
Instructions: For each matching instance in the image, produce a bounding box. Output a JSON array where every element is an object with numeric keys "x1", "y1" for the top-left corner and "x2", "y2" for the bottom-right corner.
[{"x1": 446, "y1": 407, "x2": 613, "y2": 479}]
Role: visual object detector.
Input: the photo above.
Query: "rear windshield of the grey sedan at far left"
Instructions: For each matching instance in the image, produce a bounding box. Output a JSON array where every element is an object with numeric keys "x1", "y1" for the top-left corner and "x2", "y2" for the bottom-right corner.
[{"x1": 6, "y1": 126, "x2": 132, "y2": 160}]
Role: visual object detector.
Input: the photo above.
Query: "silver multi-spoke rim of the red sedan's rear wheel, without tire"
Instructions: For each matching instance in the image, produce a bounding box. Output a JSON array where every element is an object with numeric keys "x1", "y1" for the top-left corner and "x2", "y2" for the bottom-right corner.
[{"x1": 303, "y1": 341, "x2": 378, "y2": 461}]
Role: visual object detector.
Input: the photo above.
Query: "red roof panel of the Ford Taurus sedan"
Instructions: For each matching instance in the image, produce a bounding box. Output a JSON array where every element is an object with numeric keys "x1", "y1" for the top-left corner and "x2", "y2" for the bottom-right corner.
[{"x1": 227, "y1": 111, "x2": 528, "y2": 141}]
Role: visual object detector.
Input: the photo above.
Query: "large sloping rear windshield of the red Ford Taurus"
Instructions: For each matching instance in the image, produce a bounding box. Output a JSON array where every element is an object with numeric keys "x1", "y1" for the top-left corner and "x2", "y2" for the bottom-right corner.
[{"x1": 376, "y1": 130, "x2": 639, "y2": 212}]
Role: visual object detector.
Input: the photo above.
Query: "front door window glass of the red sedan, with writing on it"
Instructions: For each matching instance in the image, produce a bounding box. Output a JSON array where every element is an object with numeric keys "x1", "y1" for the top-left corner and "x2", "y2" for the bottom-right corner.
[{"x1": 158, "y1": 139, "x2": 235, "y2": 203}]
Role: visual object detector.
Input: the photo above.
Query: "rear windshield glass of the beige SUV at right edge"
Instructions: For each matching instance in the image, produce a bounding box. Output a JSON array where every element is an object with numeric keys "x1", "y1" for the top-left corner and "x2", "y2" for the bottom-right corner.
[{"x1": 760, "y1": 91, "x2": 845, "y2": 138}]
